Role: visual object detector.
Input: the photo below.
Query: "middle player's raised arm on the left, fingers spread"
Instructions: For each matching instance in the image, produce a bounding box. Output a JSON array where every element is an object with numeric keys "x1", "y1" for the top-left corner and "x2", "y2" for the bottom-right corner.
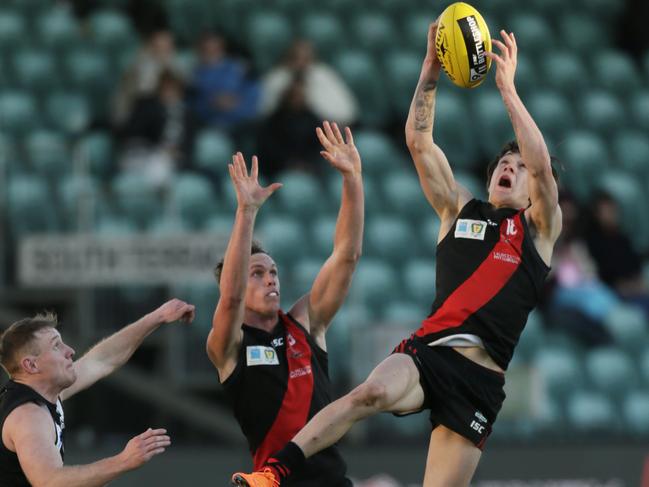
[{"x1": 207, "y1": 152, "x2": 282, "y2": 377}]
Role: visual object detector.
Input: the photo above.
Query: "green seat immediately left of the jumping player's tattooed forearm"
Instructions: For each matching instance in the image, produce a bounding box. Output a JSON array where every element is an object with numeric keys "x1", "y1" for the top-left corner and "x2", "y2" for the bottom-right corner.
[{"x1": 384, "y1": 51, "x2": 422, "y2": 120}]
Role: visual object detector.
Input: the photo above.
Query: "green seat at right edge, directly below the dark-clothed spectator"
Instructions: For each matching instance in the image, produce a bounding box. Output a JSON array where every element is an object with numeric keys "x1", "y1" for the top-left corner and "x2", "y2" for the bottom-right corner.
[{"x1": 604, "y1": 304, "x2": 649, "y2": 355}]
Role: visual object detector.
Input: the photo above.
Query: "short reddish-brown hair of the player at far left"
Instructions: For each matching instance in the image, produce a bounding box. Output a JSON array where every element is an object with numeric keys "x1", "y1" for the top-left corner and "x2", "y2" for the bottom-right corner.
[{"x1": 0, "y1": 312, "x2": 59, "y2": 376}]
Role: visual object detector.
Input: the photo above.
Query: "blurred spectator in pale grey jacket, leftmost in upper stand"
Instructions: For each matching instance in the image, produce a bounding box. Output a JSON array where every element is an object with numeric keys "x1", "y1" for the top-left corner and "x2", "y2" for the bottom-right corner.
[{"x1": 113, "y1": 30, "x2": 183, "y2": 125}]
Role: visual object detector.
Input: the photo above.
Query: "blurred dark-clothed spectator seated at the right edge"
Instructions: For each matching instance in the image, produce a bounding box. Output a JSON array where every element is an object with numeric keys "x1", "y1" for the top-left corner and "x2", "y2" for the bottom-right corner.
[{"x1": 586, "y1": 192, "x2": 649, "y2": 317}]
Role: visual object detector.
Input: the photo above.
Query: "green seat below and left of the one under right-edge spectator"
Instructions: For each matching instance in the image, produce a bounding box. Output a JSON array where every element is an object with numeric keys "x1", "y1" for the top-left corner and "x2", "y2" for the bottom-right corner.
[{"x1": 584, "y1": 347, "x2": 637, "y2": 398}]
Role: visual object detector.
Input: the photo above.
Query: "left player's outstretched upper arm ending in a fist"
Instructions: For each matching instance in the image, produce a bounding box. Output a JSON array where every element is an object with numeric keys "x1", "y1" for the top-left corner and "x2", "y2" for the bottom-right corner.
[{"x1": 61, "y1": 299, "x2": 194, "y2": 400}]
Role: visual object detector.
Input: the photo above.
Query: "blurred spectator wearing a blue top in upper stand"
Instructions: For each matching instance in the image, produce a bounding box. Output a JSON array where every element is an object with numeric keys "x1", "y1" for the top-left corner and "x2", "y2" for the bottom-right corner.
[{"x1": 192, "y1": 33, "x2": 259, "y2": 130}]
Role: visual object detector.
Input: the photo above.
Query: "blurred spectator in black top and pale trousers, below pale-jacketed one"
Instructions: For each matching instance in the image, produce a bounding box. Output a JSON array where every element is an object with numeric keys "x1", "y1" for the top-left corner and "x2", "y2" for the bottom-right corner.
[{"x1": 118, "y1": 70, "x2": 196, "y2": 188}]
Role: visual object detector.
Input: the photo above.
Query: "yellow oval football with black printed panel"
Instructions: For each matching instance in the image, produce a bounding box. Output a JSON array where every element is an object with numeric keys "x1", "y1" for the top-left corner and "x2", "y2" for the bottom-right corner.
[{"x1": 435, "y1": 2, "x2": 491, "y2": 88}]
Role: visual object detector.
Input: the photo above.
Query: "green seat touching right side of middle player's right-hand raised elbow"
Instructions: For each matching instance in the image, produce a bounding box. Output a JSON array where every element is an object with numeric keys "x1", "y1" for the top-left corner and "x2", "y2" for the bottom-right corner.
[{"x1": 365, "y1": 215, "x2": 418, "y2": 264}]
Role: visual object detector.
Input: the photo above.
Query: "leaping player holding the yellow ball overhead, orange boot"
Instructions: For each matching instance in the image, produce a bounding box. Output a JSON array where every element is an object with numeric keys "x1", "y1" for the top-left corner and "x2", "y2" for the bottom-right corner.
[{"x1": 233, "y1": 22, "x2": 561, "y2": 487}]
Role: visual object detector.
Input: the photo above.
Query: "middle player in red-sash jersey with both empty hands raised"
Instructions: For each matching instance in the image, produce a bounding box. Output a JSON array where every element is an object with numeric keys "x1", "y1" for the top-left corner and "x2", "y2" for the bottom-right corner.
[{"x1": 207, "y1": 122, "x2": 364, "y2": 487}]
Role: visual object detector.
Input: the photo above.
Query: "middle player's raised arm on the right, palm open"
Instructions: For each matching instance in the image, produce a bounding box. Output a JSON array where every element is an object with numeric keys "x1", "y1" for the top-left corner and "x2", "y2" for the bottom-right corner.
[{"x1": 291, "y1": 122, "x2": 364, "y2": 348}]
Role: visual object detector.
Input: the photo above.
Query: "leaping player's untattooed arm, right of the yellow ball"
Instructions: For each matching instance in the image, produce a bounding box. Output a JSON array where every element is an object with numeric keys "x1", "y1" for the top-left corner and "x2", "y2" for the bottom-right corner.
[{"x1": 485, "y1": 30, "x2": 561, "y2": 248}]
